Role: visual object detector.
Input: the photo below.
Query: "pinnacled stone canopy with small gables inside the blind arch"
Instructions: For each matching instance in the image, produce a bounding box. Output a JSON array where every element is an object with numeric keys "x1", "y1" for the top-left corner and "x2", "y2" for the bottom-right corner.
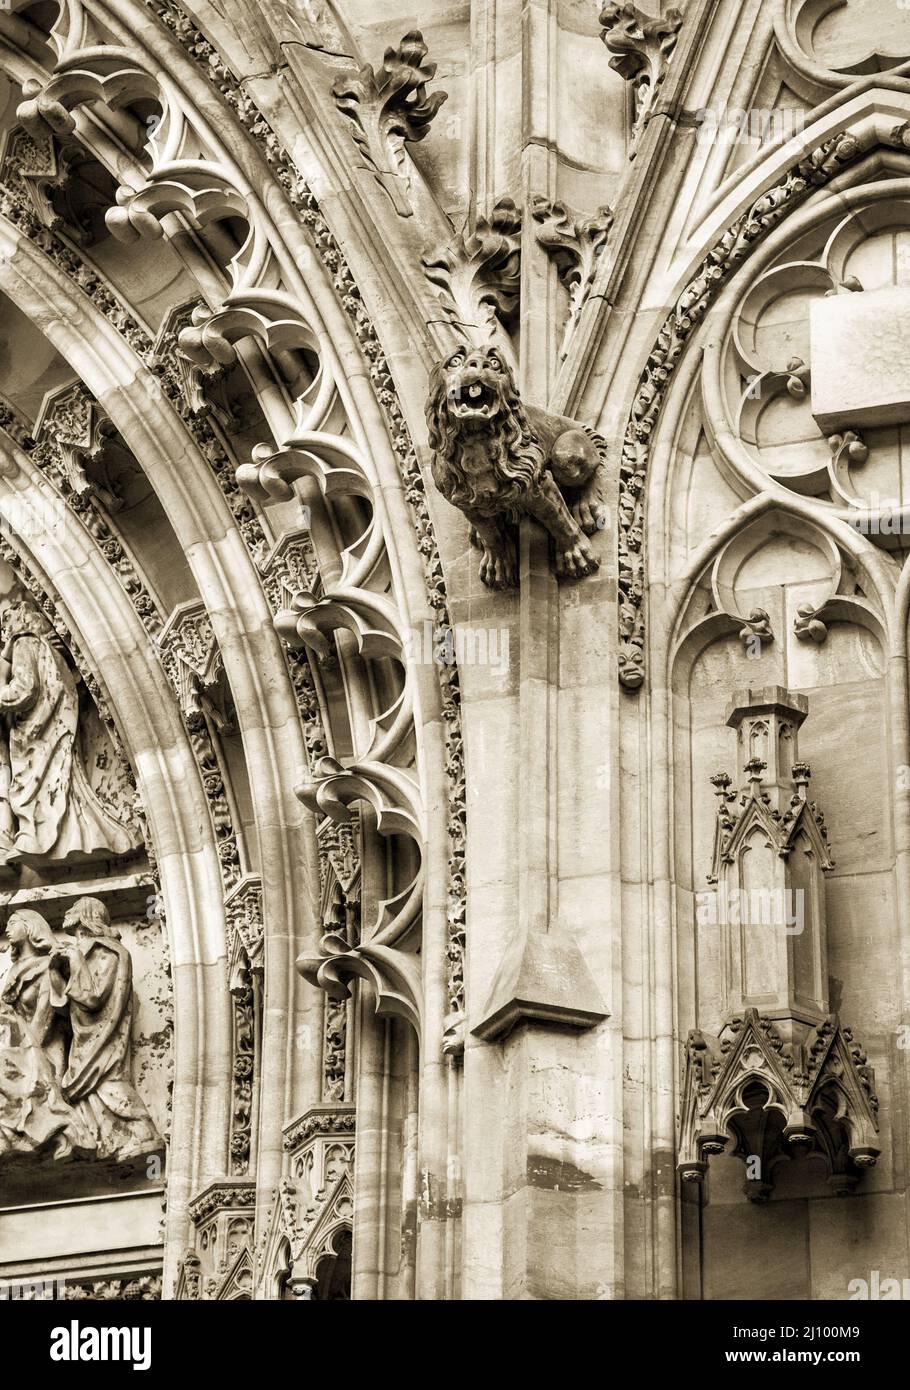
[{"x1": 678, "y1": 685, "x2": 882, "y2": 1204}]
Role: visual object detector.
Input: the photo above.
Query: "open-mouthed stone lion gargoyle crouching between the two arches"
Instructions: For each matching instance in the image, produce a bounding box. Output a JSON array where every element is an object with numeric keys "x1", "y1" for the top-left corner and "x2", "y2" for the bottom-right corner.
[{"x1": 427, "y1": 345, "x2": 606, "y2": 589}]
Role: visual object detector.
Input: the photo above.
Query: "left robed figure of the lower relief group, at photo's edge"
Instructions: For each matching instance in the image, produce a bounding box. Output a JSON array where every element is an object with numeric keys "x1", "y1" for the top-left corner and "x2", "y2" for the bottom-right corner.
[{"x1": 0, "y1": 909, "x2": 94, "y2": 1158}]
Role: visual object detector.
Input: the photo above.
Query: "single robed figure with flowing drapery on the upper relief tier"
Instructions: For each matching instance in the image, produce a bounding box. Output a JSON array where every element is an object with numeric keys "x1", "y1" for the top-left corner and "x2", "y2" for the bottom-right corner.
[{"x1": 0, "y1": 599, "x2": 133, "y2": 863}]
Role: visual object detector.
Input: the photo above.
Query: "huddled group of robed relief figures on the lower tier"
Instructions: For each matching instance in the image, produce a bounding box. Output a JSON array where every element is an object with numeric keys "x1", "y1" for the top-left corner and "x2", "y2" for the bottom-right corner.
[{"x1": 0, "y1": 898, "x2": 163, "y2": 1162}]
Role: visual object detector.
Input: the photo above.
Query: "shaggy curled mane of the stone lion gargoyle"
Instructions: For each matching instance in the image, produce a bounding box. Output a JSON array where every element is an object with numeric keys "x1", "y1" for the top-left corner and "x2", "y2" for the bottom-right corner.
[{"x1": 427, "y1": 350, "x2": 545, "y2": 512}]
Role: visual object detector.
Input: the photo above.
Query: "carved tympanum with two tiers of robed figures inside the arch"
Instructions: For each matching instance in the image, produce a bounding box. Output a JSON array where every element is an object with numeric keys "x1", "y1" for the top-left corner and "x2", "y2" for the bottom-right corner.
[{"x1": 0, "y1": 563, "x2": 172, "y2": 1205}]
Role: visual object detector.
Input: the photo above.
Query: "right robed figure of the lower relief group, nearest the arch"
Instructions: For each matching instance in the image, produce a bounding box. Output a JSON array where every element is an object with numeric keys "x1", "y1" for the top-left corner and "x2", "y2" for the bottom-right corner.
[{"x1": 53, "y1": 898, "x2": 161, "y2": 1159}]
